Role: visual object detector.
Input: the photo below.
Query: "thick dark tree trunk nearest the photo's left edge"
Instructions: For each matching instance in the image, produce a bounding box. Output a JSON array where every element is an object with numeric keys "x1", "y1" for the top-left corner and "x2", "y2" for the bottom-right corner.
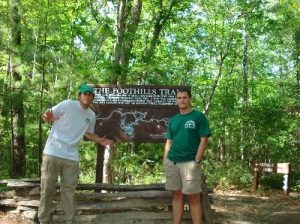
[{"x1": 7, "y1": 1, "x2": 26, "y2": 177}]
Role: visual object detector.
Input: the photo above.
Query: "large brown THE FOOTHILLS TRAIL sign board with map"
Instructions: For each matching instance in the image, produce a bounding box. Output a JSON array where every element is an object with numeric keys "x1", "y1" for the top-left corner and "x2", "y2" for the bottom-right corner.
[{"x1": 93, "y1": 85, "x2": 190, "y2": 142}]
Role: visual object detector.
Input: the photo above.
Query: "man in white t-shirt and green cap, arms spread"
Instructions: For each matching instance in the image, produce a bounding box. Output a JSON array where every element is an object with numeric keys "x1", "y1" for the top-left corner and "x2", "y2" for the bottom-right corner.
[{"x1": 38, "y1": 84, "x2": 112, "y2": 224}]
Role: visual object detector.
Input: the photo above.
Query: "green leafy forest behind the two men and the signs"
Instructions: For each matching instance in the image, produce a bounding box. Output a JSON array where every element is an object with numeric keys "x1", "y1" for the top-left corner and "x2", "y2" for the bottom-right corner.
[{"x1": 0, "y1": 0, "x2": 300, "y2": 191}]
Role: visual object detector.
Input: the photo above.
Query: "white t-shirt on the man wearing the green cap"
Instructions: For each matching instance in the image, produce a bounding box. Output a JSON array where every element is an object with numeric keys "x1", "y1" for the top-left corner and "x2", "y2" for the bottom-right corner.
[{"x1": 44, "y1": 100, "x2": 96, "y2": 161}]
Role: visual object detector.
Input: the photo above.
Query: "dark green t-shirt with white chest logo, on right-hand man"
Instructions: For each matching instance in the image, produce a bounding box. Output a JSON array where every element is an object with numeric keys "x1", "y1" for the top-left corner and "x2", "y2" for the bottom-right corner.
[{"x1": 166, "y1": 110, "x2": 211, "y2": 162}]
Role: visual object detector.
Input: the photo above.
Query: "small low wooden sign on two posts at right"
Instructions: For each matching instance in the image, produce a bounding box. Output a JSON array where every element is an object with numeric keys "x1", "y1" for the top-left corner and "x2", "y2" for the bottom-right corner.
[{"x1": 253, "y1": 162, "x2": 291, "y2": 195}]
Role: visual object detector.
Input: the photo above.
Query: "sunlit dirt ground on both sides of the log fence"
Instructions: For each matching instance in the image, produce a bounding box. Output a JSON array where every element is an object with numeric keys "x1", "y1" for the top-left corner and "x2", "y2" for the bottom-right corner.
[{"x1": 0, "y1": 191, "x2": 300, "y2": 224}]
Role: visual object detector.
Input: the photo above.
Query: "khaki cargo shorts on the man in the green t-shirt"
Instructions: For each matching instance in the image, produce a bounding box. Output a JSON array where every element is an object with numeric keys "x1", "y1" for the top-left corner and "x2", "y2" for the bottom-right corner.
[{"x1": 163, "y1": 158, "x2": 202, "y2": 195}]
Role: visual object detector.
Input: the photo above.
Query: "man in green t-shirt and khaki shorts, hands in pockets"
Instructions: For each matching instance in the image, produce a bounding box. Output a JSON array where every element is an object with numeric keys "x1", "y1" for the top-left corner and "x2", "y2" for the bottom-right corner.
[{"x1": 163, "y1": 89, "x2": 211, "y2": 224}]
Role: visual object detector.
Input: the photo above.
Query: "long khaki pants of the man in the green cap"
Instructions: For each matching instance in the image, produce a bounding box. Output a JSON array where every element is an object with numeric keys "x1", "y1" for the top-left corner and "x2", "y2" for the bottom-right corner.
[{"x1": 38, "y1": 154, "x2": 79, "y2": 223}]
